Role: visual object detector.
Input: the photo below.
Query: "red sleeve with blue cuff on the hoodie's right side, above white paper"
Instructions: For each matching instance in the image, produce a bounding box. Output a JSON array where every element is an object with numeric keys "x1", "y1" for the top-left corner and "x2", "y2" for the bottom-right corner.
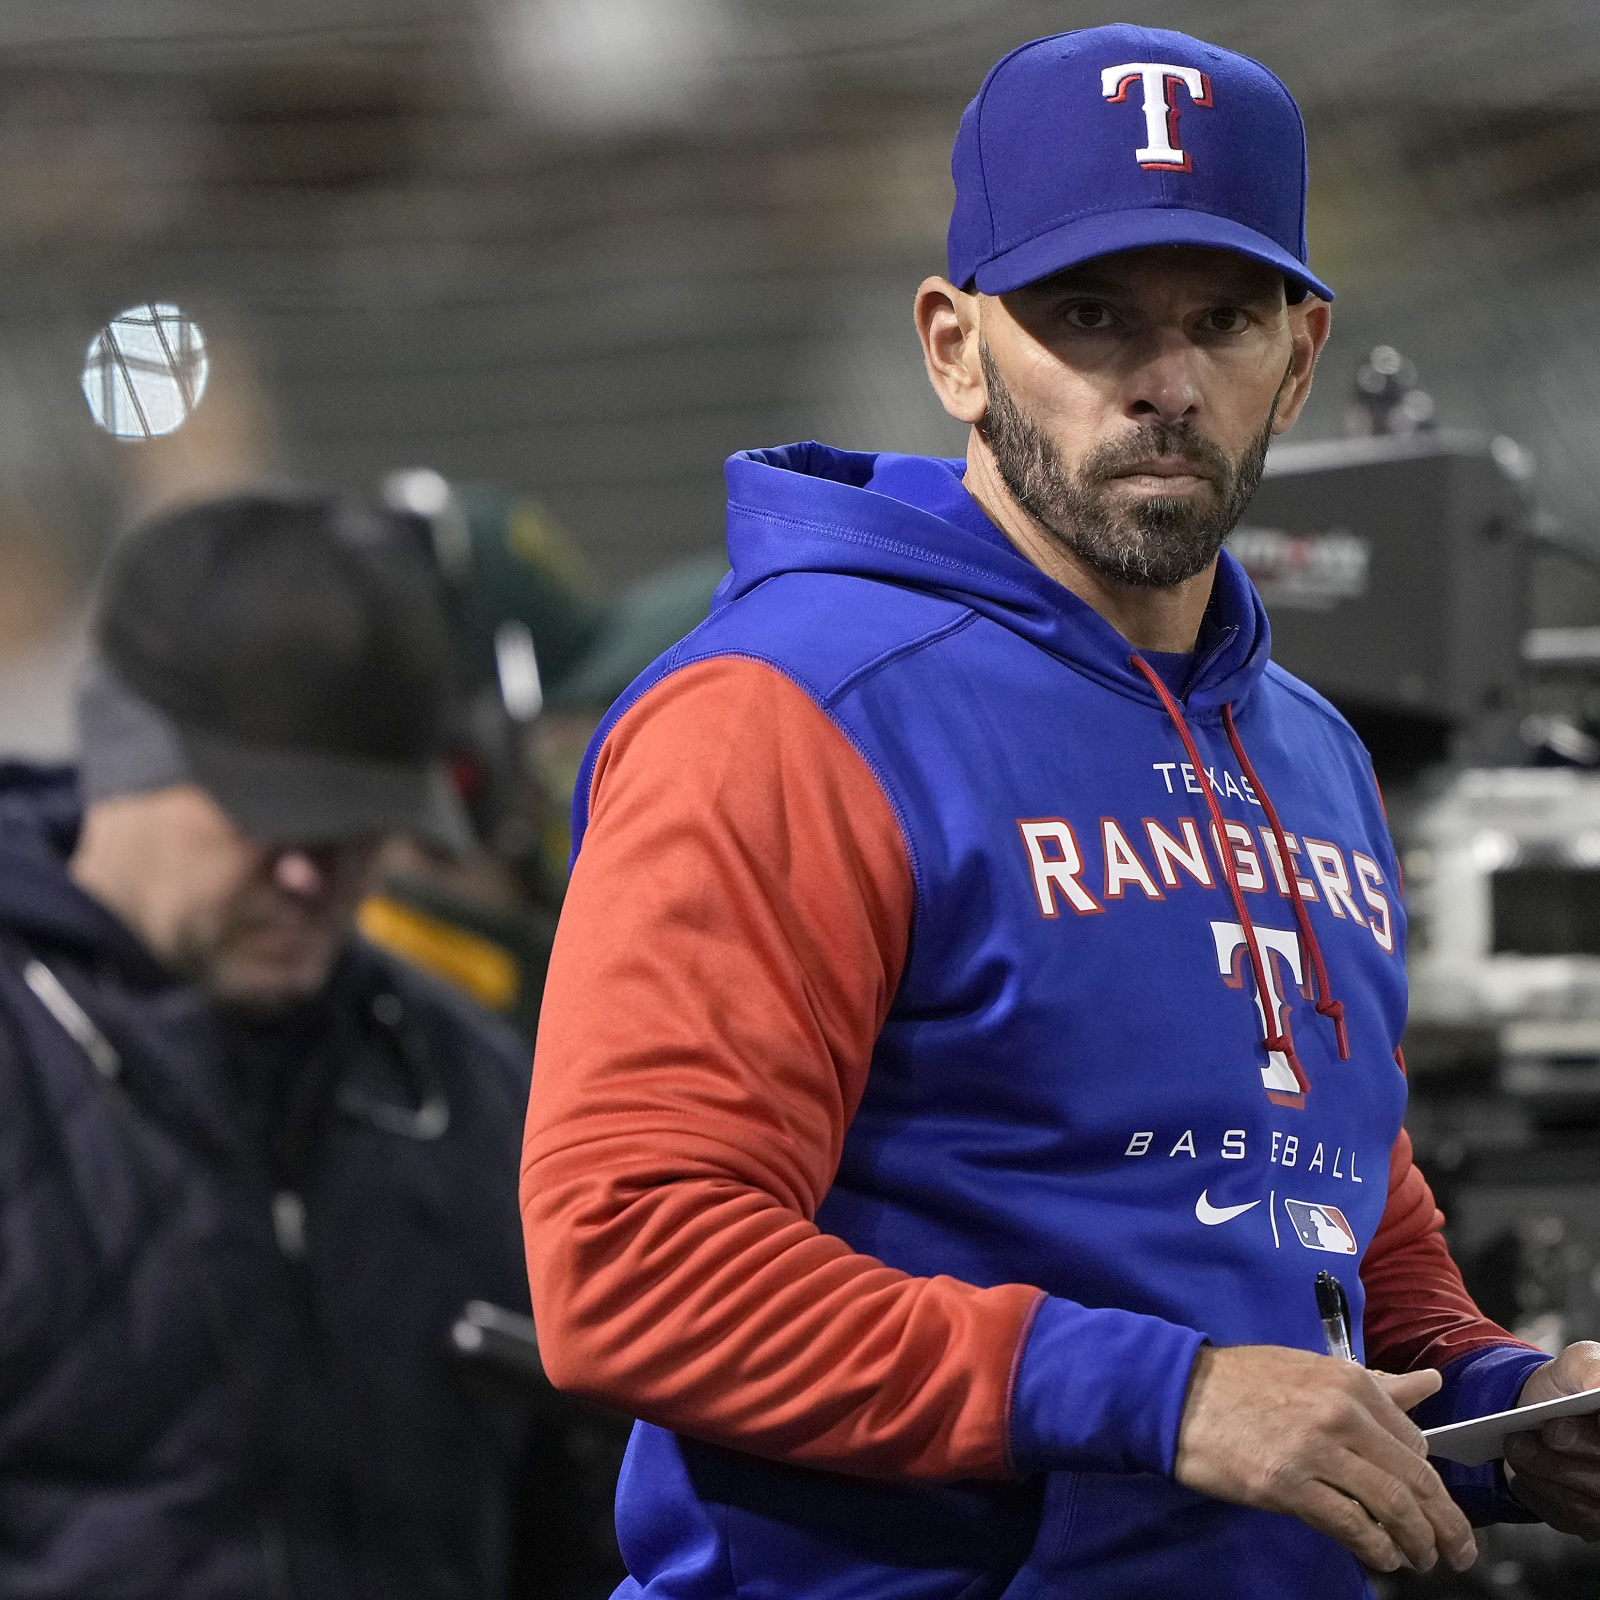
[{"x1": 1362, "y1": 1130, "x2": 1549, "y2": 1523}]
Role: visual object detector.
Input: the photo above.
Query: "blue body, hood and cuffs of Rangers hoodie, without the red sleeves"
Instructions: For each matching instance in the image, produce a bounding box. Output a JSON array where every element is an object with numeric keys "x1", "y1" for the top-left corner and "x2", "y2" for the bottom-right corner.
[{"x1": 574, "y1": 445, "x2": 1542, "y2": 1600}]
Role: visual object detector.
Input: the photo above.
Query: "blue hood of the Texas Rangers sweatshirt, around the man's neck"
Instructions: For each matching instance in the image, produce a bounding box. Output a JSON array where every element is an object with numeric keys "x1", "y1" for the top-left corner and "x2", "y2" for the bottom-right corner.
[{"x1": 717, "y1": 443, "x2": 1272, "y2": 710}]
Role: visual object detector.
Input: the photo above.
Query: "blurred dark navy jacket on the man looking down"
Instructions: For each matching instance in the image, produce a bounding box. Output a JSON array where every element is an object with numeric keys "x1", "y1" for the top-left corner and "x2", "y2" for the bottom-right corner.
[{"x1": 0, "y1": 766, "x2": 540, "y2": 1600}]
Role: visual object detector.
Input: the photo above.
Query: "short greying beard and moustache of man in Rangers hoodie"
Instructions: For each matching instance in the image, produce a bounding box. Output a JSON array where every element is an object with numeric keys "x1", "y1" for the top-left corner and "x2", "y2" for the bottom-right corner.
[{"x1": 978, "y1": 341, "x2": 1278, "y2": 589}]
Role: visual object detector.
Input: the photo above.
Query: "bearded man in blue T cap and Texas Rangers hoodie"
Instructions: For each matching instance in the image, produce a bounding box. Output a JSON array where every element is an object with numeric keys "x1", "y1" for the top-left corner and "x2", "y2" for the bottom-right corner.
[{"x1": 523, "y1": 26, "x2": 1600, "y2": 1600}]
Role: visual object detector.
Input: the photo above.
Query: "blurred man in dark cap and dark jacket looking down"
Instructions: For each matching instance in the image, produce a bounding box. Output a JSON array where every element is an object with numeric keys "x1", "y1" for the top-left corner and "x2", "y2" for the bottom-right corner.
[{"x1": 0, "y1": 496, "x2": 604, "y2": 1600}]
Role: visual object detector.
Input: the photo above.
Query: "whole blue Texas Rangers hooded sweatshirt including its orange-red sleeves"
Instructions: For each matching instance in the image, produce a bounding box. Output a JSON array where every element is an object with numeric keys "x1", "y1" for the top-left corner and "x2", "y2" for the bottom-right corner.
[{"x1": 523, "y1": 445, "x2": 1544, "y2": 1600}]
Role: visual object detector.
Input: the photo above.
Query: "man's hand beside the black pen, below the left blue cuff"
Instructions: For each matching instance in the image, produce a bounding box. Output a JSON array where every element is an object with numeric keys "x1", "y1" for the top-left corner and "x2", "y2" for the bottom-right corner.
[{"x1": 1174, "y1": 1344, "x2": 1472, "y2": 1573}]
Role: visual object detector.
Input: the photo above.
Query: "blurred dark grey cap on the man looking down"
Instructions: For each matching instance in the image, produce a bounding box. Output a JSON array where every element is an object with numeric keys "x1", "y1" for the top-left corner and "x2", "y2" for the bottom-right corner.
[{"x1": 80, "y1": 493, "x2": 467, "y2": 846}]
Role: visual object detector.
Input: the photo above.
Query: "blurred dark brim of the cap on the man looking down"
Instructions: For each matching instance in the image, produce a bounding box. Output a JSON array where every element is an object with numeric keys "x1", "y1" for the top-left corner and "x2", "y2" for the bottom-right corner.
[{"x1": 178, "y1": 728, "x2": 472, "y2": 853}]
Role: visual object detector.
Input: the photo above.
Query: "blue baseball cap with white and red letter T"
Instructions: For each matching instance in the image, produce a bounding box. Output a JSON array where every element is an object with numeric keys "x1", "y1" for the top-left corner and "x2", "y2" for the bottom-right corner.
[{"x1": 950, "y1": 22, "x2": 1333, "y2": 301}]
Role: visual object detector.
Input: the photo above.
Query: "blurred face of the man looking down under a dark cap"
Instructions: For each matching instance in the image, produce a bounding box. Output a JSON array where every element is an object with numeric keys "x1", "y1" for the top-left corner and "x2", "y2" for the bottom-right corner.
[{"x1": 91, "y1": 784, "x2": 379, "y2": 1014}]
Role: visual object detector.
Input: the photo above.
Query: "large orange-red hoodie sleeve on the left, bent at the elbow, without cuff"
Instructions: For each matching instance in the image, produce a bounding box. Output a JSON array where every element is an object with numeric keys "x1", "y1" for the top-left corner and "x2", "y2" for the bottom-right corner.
[{"x1": 522, "y1": 659, "x2": 1042, "y2": 1478}]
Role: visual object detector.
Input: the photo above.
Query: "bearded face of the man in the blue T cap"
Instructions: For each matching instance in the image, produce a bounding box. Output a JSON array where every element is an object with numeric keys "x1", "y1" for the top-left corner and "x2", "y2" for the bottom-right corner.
[{"x1": 979, "y1": 246, "x2": 1296, "y2": 589}]
